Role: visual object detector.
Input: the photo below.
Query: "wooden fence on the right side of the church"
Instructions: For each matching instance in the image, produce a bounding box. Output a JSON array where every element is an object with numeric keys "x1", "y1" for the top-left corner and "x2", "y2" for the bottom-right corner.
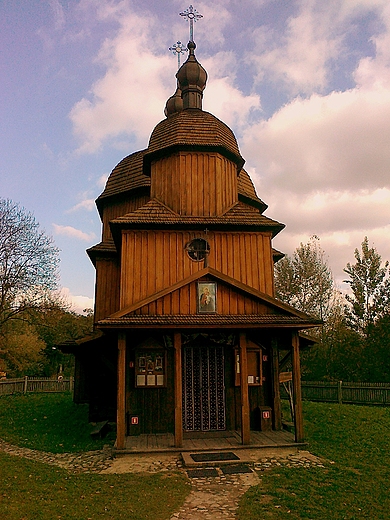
[{"x1": 281, "y1": 381, "x2": 390, "y2": 406}]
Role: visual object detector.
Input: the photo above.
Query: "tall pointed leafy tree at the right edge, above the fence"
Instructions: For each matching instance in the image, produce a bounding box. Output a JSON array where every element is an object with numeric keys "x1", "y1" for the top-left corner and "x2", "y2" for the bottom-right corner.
[{"x1": 344, "y1": 237, "x2": 390, "y2": 336}]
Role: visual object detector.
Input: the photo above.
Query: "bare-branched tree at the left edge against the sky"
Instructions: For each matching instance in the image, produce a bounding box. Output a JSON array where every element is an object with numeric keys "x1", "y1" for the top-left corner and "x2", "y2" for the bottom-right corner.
[{"x1": 0, "y1": 199, "x2": 59, "y2": 335}]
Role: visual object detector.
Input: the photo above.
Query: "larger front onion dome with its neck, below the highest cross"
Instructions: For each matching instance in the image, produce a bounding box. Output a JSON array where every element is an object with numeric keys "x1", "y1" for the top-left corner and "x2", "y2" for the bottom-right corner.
[{"x1": 176, "y1": 42, "x2": 207, "y2": 109}]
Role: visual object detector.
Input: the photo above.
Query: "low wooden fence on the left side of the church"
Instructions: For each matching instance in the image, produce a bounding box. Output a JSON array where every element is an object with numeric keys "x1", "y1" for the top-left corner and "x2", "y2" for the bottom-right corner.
[{"x1": 0, "y1": 376, "x2": 74, "y2": 396}]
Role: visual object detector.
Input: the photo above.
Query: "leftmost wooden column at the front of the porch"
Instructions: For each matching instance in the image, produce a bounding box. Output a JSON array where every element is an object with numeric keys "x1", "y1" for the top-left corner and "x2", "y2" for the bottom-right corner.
[{"x1": 116, "y1": 332, "x2": 126, "y2": 450}]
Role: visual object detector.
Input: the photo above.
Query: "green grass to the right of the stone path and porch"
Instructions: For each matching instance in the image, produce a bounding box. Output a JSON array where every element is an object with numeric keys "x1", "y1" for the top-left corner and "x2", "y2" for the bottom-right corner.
[{"x1": 238, "y1": 402, "x2": 390, "y2": 520}]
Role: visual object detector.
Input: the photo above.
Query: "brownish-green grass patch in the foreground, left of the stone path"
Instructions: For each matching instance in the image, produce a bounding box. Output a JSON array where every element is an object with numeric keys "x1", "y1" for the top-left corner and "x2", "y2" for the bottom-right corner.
[{"x1": 0, "y1": 453, "x2": 189, "y2": 520}]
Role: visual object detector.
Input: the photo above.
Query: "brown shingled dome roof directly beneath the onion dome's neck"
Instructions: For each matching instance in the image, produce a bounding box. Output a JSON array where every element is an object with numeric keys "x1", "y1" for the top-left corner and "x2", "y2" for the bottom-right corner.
[{"x1": 144, "y1": 108, "x2": 245, "y2": 174}]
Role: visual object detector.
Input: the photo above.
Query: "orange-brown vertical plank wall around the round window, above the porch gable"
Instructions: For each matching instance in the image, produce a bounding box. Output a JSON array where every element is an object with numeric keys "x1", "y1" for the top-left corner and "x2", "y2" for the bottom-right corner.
[{"x1": 120, "y1": 230, "x2": 273, "y2": 306}]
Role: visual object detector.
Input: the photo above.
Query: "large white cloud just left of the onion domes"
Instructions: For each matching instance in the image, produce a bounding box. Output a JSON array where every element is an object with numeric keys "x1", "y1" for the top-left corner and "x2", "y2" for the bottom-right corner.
[{"x1": 70, "y1": 7, "x2": 175, "y2": 153}]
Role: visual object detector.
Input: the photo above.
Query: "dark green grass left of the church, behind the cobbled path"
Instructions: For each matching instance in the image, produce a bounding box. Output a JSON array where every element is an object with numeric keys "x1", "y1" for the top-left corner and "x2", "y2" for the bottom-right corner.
[{"x1": 0, "y1": 393, "x2": 115, "y2": 453}]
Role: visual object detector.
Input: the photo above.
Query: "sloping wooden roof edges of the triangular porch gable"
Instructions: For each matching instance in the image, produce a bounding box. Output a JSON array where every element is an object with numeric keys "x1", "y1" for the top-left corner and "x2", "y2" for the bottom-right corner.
[{"x1": 108, "y1": 267, "x2": 322, "y2": 325}]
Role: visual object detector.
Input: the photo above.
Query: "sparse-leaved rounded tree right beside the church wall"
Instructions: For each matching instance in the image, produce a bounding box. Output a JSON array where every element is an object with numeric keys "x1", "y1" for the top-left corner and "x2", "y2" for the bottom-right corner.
[{"x1": 275, "y1": 236, "x2": 334, "y2": 319}]
